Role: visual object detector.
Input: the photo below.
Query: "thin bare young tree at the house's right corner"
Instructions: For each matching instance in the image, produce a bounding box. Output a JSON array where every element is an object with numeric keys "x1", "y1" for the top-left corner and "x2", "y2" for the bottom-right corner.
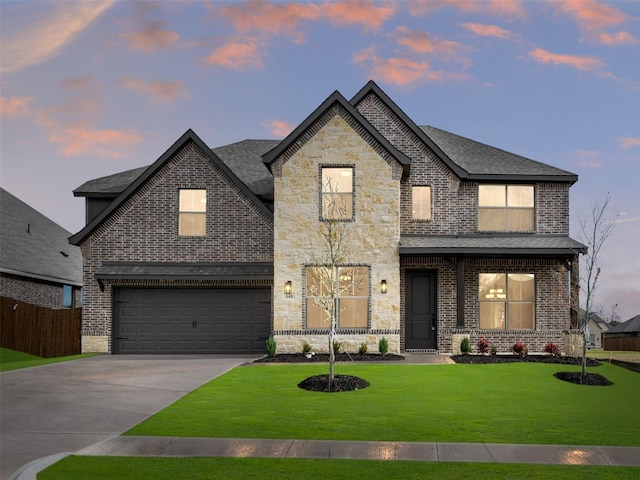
[{"x1": 579, "y1": 194, "x2": 614, "y2": 383}]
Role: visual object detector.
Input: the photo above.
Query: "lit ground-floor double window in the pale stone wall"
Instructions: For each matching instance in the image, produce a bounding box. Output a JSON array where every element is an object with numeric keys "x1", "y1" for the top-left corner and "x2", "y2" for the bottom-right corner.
[{"x1": 305, "y1": 266, "x2": 369, "y2": 329}]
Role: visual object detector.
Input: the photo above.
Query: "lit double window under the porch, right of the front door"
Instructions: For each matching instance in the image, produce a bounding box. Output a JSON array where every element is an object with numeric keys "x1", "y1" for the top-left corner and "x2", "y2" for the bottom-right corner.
[{"x1": 479, "y1": 273, "x2": 536, "y2": 330}]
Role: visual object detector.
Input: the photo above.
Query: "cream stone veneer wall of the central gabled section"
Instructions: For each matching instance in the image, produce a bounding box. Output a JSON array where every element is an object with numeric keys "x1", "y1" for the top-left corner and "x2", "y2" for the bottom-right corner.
[{"x1": 272, "y1": 108, "x2": 402, "y2": 353}]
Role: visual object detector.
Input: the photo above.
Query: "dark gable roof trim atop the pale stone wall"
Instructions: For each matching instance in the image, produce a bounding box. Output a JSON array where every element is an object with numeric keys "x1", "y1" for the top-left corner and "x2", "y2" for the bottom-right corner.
[{"x1": 262, "y1": 91, "x2": 411, "y2": 175}]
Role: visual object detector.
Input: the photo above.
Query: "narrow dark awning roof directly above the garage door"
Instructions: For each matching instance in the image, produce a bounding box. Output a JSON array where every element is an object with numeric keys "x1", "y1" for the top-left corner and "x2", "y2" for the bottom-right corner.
[{"x1": 95, "y1": 262, "x2": 273, "y2": 280}]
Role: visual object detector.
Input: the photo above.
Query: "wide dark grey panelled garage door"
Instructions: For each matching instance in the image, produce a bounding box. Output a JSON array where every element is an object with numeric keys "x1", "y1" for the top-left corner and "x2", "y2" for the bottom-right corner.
[{"x1": 114, "y1": 288, "x2": 271, "y2": 353}]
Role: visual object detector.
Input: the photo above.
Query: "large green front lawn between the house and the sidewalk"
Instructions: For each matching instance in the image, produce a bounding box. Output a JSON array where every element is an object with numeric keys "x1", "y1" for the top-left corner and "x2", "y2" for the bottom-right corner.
[{"x1": 127, "y1": 363, "x2": 640, "y2": 446}]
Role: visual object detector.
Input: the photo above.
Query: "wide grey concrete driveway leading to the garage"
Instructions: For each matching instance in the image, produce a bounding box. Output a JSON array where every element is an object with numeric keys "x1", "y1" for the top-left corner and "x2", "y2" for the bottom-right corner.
[{"x1": 0, "y1": 355, "x2": 257, "y2": 479}]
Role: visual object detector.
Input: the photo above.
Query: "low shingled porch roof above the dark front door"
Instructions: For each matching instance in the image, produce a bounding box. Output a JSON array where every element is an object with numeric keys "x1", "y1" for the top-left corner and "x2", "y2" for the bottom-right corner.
[{"x1": 400, "y1": 234, "x2": 585, "y2": 256}]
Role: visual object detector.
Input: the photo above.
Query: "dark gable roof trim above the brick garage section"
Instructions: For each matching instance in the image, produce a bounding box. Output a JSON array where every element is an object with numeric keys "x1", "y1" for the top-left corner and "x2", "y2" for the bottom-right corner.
[{"x1": 69, "y1": 129, "x2": 273, "y2": 245}]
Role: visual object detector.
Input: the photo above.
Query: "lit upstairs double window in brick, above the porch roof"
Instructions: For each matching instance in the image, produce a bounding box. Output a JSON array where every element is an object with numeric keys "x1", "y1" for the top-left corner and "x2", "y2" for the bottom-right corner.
[{"x1": 478, "y1": 185, "x2": 534, "y2": 232}]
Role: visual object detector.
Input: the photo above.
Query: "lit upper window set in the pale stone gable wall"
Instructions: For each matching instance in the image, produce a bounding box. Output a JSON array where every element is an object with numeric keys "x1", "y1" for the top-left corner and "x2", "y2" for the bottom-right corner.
[{"x1": 320, "y1": 167, "x2": 354, "y2": 220}]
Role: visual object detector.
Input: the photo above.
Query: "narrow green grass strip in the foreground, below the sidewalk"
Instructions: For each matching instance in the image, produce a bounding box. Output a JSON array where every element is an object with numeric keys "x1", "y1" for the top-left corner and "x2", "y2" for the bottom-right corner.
[{"x1": 38, "y1": 457, "x2": 640, "y2": 480}]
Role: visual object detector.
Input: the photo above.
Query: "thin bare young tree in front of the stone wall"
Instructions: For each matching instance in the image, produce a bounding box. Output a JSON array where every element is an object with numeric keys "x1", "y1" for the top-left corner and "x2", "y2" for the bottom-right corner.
[{"x1": 307, "y1": 173, "x2": 362, "y2": 390}]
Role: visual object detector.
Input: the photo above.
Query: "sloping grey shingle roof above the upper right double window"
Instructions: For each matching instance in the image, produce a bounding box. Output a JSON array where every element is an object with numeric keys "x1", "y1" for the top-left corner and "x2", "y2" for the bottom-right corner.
[{"x1": 420, "y1": 126, "x2": 578, "y2": 182}]
